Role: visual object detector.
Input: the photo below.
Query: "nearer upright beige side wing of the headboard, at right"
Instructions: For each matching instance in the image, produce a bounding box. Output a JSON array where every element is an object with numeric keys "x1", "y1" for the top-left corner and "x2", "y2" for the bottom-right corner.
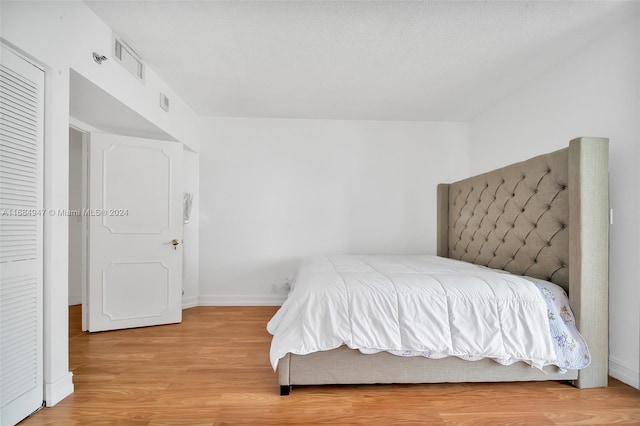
[{"x1": 569, "y1": 138, "x2": 609, "y2": 388}]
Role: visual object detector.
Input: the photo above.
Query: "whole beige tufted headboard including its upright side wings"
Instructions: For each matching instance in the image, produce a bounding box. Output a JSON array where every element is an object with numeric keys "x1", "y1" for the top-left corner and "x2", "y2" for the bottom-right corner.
[{"x1": 438, "y1": 138, "x2": 609, "y2": 387}]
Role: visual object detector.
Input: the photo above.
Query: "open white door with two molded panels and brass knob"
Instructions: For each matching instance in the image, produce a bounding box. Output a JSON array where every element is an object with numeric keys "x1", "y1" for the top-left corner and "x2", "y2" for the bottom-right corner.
[{"x1": 84, "y1": 133, "x2": 183, "y2": 331}]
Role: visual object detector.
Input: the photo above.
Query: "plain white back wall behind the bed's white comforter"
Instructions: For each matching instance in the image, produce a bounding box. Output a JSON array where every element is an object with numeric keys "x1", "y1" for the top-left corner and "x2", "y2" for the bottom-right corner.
[{"x1": 200, "y1": 119, "x2": 469, "y2": 305}]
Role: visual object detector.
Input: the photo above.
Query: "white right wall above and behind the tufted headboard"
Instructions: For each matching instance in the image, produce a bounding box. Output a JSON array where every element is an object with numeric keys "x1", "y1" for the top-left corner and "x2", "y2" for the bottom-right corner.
[{"x1": 470, "y1": 17, "x2": 640, "y2": 387}]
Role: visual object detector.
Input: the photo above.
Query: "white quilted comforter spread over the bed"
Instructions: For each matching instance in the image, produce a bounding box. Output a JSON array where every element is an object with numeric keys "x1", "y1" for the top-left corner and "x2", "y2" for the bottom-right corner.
[{"x1": 267, "y1": 256, "x2": 556, "y2": 370}]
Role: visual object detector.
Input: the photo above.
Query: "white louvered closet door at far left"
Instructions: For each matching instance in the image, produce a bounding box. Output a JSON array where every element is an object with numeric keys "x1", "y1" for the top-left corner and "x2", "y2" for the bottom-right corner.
[{"x1": 0, "y1": 46, "x2": 44, "y2": 426}]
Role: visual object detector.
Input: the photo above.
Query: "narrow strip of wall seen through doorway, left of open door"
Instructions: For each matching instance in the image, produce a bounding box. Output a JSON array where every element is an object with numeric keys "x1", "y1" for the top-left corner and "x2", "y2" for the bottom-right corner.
[{"x1": 68, "y1": 129, "x2": 82, "y2": 306}]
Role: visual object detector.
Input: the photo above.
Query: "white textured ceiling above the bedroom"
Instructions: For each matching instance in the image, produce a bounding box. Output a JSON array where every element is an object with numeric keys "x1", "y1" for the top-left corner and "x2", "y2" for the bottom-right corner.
[{"x1": 85, "y1": 0, "x2": 638, "y2": 121}]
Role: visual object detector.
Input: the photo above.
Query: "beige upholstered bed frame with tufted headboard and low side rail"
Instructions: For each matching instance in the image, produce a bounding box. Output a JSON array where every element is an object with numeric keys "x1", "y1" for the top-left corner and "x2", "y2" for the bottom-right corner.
[{"x1": 278, "y1": 137, "x2": 609, "y2": 395}]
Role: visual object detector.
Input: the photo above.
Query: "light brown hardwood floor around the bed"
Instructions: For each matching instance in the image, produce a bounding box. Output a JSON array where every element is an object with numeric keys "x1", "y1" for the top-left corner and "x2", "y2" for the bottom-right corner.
[{"x1": 21, "y1": 306, "x2": 640, "y2": 426}]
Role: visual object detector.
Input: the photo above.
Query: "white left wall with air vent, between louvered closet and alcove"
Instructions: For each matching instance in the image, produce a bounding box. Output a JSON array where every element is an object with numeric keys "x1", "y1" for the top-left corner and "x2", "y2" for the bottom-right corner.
[{"x1": 0, "y1": 0, "x2": 200, "y2": 406}]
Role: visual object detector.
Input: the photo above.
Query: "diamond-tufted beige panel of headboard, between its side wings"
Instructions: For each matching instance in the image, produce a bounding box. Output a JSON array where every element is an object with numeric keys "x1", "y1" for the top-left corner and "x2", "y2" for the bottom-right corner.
[{"x1": 440, "y1": 148, "x2": 569, "y2": 290}]
